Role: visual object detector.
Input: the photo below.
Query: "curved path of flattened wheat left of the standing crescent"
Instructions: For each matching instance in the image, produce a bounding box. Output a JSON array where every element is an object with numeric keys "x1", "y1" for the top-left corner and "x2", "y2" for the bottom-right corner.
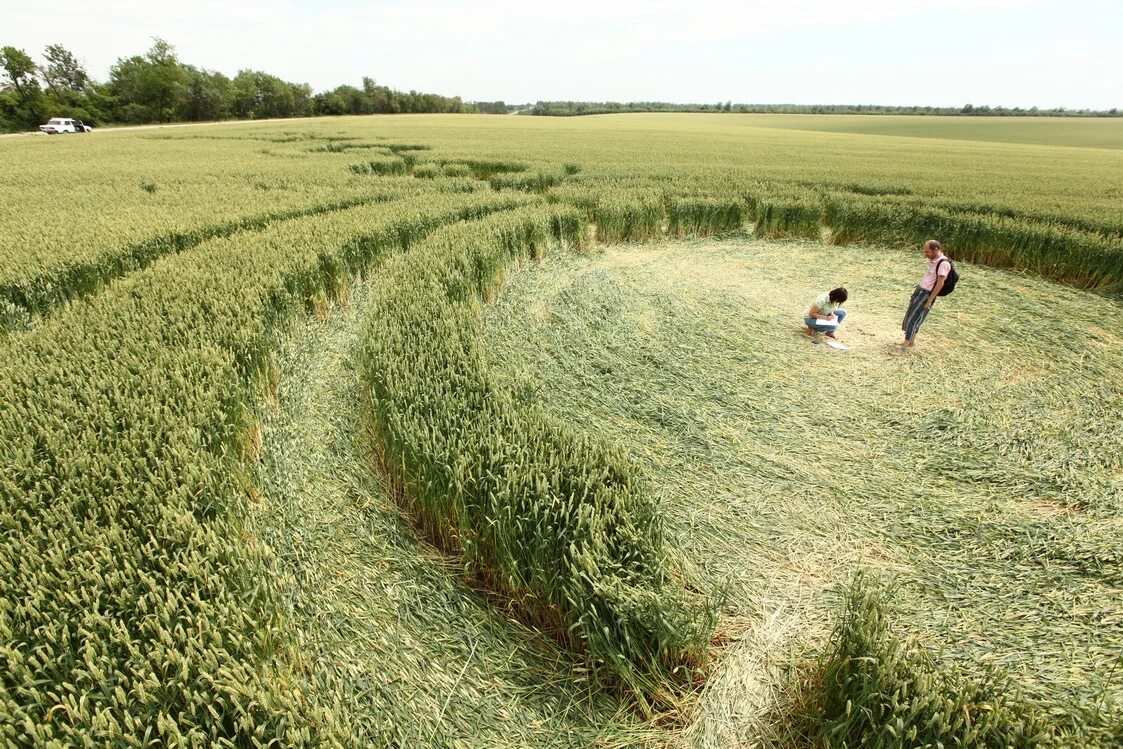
[{"x1": 253, "y1": 284, "x2": 667, "y2": 748}]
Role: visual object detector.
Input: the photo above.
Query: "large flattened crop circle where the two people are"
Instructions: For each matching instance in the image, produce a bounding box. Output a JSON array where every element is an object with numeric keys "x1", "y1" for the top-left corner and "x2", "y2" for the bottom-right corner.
[{"x1": 485, "y1": 236, "x2": 1123, "y2": 747}]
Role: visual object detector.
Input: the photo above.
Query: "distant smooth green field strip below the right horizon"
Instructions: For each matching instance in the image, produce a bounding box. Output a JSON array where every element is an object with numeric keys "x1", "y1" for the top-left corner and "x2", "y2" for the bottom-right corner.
[{"x1": 732, "y1": 115, "x2": 1123, "y2": 148}]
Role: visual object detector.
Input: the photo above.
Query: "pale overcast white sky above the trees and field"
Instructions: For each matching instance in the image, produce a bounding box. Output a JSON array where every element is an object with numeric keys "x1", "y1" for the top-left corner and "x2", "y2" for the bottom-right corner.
[{"x1": 8, "y1": 0, "x2": 1123, "y2": 109}]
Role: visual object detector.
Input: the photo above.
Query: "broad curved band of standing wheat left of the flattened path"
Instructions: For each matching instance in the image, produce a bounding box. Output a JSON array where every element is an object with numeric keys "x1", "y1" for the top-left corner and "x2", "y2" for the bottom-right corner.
[{"x1": 0, "y1": 188, "x2": 529, "y2": 747}]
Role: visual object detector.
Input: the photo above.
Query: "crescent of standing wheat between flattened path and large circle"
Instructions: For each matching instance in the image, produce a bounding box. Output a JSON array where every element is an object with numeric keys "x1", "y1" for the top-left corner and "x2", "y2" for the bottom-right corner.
[{"x1": 363, "y1": 208, "x2": 716, "y2": 709}]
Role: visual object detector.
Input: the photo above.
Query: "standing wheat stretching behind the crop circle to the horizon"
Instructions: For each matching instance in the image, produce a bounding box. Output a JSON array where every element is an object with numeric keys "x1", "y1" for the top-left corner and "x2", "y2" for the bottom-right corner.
[{"x1": 0, "y1": 115, "x2": 1123, "y2": 327}]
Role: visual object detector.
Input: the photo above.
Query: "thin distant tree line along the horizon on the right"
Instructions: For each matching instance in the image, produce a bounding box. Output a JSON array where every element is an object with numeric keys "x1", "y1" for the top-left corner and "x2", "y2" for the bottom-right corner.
[{"x1": 519, "y1": 101, "x2": 1123, "y2": 117}]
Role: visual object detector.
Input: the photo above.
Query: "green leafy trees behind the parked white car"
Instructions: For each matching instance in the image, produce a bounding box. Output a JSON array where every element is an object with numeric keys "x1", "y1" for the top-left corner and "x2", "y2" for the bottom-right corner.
[{"x1": 0, "y1": 38, "x2": 508, "y2": 131}]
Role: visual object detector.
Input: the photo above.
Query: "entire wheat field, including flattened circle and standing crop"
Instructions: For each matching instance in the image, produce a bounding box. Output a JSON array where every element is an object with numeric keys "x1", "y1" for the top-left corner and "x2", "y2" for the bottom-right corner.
[{"x1": 0, "y1": 115, "x2": 1123, "y2": 747}]
